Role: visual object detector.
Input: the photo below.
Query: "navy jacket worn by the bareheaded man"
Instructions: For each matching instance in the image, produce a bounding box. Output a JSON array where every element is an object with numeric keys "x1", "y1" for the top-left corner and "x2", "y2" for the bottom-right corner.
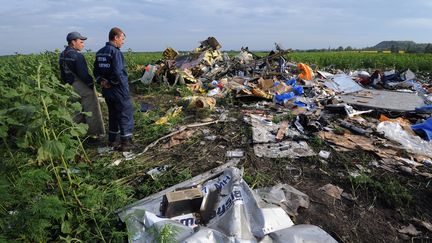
[{"x1": 93, "y1": 42, "x2": 129, "y2": 97}]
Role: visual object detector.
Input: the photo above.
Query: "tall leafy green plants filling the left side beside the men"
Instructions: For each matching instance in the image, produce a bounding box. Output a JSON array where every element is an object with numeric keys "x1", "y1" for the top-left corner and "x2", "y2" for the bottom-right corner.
[{"x1": 0, "y1": 52, "x2": 137, "y2": 242}]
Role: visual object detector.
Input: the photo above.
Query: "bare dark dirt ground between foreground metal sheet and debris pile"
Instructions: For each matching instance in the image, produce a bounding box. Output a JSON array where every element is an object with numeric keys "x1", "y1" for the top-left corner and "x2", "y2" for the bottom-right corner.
[{"x1": 98, "y1": 88, "x2": 432, "y2": 242}]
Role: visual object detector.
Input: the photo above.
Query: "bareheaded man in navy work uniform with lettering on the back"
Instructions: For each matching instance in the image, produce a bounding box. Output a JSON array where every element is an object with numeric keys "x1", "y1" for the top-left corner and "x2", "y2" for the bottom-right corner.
[{"x1": 93, "y1": 27, "x2": 134, "y2": 151}]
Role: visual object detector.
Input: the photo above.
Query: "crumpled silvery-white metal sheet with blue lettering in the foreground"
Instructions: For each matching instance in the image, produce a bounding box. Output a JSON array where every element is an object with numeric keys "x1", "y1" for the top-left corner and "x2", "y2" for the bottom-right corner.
[{"x1": 119, "y1": 164, "x2": 336, "y2": 242}]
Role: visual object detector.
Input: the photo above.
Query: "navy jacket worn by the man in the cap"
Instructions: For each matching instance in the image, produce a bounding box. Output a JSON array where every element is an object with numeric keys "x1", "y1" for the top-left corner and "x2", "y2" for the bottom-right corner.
[{"x1": 59, "y1": 46, "x2": 93, "y2": 87}]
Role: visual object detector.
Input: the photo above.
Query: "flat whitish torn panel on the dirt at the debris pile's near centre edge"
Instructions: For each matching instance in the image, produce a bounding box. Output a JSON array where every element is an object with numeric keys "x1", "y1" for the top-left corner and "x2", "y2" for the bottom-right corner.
[{"x1": 254, "y1": 141, "x2": 315, "y2": 158}]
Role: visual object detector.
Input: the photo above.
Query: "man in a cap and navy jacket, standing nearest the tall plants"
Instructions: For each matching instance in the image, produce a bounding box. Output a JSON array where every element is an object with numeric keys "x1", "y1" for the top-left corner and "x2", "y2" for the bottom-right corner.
[{"x1": 59, "y1": 31, "x2": 105, "y2": 138}]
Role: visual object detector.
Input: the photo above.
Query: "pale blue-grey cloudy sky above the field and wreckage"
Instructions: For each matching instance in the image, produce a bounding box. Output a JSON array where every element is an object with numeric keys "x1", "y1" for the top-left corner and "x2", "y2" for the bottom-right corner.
[{"x1": 0, "y1": 0, "x2": 432, "y2": 55}]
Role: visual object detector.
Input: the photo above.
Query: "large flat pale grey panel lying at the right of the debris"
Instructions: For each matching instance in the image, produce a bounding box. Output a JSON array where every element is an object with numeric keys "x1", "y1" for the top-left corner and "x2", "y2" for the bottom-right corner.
[{"x1": 341, "y1": 89, "x2": 425, "y2": 112}]
